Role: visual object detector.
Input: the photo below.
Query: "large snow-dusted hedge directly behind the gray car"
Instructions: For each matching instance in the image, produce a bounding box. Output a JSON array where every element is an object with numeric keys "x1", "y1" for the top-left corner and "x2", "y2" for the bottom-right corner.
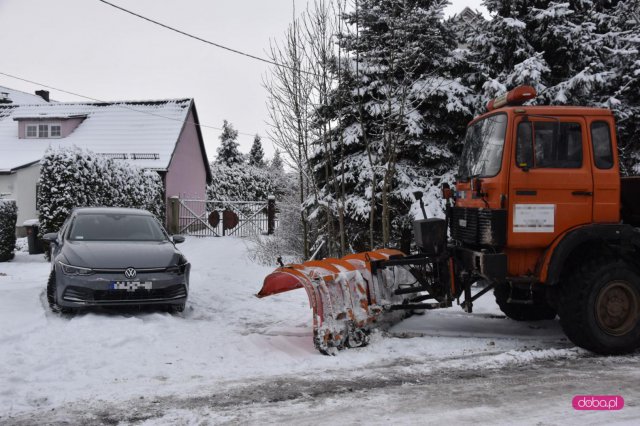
[{"x1": 38, "y1": 147, "x2": 165, "y2": 238}]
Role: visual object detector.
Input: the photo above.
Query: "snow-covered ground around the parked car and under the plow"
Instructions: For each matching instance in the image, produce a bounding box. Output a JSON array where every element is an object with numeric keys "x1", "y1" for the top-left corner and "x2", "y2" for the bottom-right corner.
[{"x1": 0, "y1": 238, "x2": 640, "y2": 424}]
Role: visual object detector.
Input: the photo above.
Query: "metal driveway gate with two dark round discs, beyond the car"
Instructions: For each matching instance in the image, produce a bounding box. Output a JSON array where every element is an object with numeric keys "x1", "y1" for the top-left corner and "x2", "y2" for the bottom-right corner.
[{"x1": 169, "y1": 197, "x2": 278, "y2": 237}]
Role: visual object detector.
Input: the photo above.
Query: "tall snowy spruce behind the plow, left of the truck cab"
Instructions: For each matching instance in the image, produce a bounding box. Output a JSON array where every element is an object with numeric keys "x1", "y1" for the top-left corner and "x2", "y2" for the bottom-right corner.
[{"x1": 312, "y1": 0, "x2": 471, "y2": 249}]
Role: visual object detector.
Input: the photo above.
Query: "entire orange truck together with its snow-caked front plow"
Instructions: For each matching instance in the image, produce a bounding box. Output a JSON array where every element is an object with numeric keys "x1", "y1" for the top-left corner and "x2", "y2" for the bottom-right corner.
[{"x1": 258, "y1": 86, "x2": 640, "y2": 354}]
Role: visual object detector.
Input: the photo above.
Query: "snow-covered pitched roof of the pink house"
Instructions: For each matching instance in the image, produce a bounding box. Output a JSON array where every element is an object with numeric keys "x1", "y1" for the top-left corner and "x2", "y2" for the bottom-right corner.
[{"x1": 0, "y1": 99, "x2": 204, "y2": 173}]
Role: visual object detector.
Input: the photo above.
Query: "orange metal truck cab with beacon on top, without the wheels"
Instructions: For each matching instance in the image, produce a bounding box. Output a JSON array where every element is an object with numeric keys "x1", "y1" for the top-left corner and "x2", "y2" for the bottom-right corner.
[{"x1": 450, "y1": 89, "x2": 620, "y2": 282}]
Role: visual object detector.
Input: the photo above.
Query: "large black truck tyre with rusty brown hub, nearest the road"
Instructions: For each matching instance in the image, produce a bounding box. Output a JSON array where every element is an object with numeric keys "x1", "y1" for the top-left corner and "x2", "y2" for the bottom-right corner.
[{"x1": 559, "y1": 258, "x2": 640, "y2": 355}]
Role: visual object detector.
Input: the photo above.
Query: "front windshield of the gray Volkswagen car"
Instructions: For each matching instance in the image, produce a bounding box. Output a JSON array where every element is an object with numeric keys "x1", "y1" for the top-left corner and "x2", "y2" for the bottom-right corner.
[{"x1": 69, "y1": 213, "x2": 166, "y2": 241}]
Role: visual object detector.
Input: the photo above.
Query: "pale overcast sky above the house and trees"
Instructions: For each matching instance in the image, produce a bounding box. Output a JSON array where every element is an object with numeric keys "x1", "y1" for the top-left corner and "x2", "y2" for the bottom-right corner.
[{"x1": 0, "y1": 0, "x2": 482, "y2": 159}]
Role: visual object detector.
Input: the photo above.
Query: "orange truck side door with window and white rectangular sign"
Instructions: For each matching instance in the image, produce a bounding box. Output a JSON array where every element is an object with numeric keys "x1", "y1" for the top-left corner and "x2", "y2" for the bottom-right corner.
[{"x1": 508, "y1": 116, "x2": 593, "y2": 248}]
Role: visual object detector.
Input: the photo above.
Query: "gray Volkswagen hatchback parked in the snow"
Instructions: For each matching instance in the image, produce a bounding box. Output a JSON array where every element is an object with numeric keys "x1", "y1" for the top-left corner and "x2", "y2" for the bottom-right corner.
[{"x1": 43, "y1": 207, "x2": 190, "y2": 312}]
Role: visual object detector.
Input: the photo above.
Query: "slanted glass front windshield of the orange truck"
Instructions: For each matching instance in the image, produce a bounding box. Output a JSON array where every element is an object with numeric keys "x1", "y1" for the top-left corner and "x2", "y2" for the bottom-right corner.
[{"x1": 458, "y1": 114, "x2": 507, "y2": 180}]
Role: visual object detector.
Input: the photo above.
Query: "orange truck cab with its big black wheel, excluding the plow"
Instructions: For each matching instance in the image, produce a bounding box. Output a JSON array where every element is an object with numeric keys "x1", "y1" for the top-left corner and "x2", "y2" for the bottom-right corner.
[{"x1": 447, "y1": 86, "x2": 640, "y2": 353}]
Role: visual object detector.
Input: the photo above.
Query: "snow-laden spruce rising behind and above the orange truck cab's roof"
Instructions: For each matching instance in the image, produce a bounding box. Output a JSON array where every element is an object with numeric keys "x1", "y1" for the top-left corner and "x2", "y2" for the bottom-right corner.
[{"x1": 468, "y1": 0, "x2": 640, "y2": 173}]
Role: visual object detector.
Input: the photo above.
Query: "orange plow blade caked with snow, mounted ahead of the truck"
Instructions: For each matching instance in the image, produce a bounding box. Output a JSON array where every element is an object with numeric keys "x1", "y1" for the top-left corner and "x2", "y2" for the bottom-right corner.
[{"x1": 257, "y1": 249, "x2": 406, "y2": 355}]
